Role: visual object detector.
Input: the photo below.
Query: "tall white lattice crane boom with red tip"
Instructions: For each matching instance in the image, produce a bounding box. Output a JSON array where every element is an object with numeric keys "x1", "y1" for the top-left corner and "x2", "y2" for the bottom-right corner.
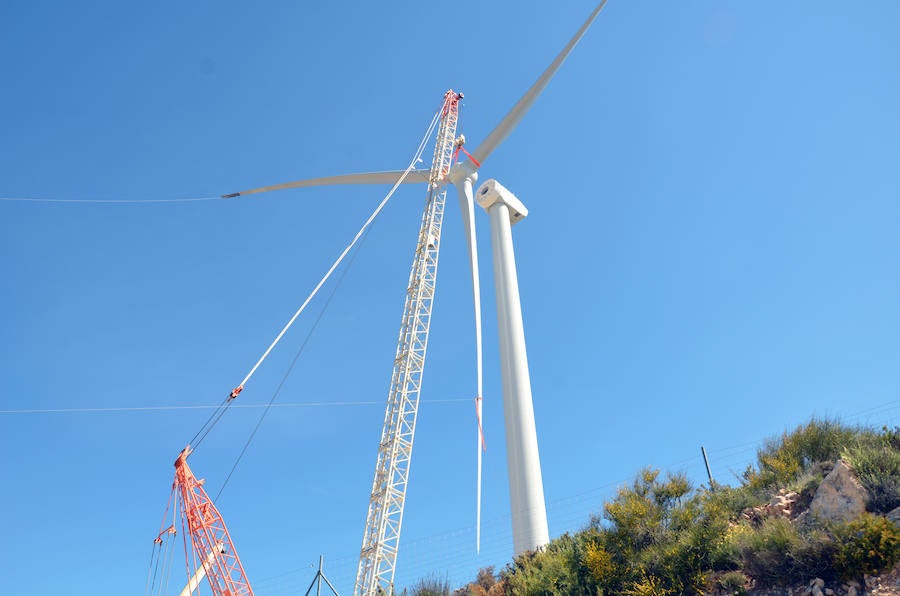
[{"x1": 354, "y1": 90, "x2": 462, "y2": 596}]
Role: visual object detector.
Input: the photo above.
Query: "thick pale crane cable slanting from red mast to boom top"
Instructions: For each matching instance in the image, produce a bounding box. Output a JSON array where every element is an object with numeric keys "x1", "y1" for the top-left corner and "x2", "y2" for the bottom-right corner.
[{"x1": 189, "y1": 104, "x2": 443, "y2": 450}]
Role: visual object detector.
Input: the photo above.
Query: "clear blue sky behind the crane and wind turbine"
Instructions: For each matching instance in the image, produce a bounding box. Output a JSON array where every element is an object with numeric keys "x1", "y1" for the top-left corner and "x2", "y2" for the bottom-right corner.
[{"x1": 0, "y1": 0, "x2": 900, "y2": 594}]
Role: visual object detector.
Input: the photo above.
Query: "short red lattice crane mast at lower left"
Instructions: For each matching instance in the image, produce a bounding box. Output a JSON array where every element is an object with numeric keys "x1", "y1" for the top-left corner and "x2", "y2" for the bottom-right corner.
[{"x1": 175, "y1": 446, "x2": 253, "y2": 596}]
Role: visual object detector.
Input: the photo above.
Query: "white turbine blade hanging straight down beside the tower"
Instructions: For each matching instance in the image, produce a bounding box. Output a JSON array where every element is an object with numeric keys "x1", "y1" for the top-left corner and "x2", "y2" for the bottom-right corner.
[{"x1": 455, "y1": 174, "x2": 484, "y2": 553}]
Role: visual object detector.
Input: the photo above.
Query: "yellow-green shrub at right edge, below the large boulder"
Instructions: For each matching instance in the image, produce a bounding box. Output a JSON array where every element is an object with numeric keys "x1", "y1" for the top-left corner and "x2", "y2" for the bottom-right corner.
[{"x1": 834, "y1": 513, "x2": 900, "y2": 580}]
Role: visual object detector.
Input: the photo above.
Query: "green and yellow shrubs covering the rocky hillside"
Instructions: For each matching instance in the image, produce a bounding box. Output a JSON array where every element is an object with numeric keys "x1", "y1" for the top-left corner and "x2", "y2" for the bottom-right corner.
[{"x1": 409, "y1": 419, "x2": 900, "y2": 596}]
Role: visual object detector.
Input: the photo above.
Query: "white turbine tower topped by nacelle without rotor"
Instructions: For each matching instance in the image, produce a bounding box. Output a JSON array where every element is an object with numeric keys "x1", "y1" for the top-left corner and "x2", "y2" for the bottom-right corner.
[{"x1": 476, "y1": 180, "x2": 550, "y2": 555}]
